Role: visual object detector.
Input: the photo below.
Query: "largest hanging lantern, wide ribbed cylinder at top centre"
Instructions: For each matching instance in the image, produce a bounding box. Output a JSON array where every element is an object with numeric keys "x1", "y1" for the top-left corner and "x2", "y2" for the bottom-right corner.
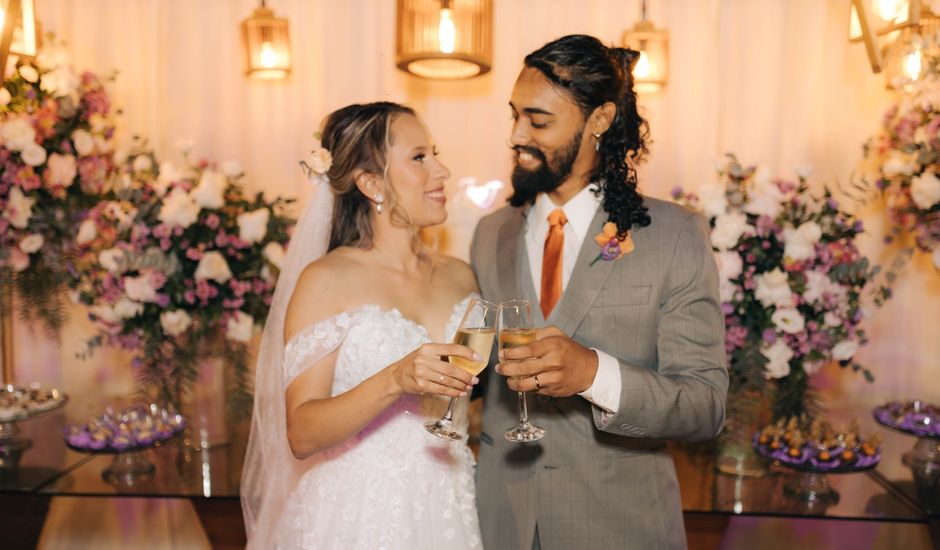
[{"x1": 395, "y1": 0, "x2": 493, "y2": 80}]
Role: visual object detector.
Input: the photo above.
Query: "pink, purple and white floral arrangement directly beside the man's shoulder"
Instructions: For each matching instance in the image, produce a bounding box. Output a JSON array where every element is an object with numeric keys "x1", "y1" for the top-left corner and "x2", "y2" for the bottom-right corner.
[{"x1": 673, "y1": 155, "x2": 890, "y2": 418}]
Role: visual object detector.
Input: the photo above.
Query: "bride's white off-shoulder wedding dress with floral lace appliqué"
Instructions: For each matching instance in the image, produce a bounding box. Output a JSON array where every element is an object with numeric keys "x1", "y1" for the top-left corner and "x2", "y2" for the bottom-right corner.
[{"x1": 276, "y1": 297, "x2": 482, "y2": 550}]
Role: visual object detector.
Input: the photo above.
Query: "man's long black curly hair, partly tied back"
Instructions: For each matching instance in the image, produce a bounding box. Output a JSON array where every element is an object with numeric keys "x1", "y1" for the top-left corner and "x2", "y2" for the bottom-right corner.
[{"x1": 525, "y1": 34, "x2": 650, "y2": 236}]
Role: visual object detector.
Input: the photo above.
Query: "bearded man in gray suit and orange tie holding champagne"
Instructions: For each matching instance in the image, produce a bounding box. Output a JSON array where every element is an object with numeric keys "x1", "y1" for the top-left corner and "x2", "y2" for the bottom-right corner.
[{"x1": 471, "y1": 35, "x2": 728, "y2": 550}]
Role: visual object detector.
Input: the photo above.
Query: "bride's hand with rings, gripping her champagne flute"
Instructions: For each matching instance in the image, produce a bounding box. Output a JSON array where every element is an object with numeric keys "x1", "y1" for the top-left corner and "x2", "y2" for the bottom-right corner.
[{"x1": 392, "y1": 344, "x2": 483, "y2": 397}]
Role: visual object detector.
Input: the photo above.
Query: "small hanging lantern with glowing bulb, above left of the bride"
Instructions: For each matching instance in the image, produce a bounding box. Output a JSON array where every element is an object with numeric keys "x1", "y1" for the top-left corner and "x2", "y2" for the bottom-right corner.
[{"x1": 242, "y1": 0, "x2": 290, "y2": 79}]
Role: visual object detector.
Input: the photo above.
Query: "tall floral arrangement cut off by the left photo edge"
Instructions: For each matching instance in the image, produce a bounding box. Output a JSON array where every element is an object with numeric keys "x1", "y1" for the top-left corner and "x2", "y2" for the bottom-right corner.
[{"x1": 0, "y1": 40, "x2": 114, "y2": 330}]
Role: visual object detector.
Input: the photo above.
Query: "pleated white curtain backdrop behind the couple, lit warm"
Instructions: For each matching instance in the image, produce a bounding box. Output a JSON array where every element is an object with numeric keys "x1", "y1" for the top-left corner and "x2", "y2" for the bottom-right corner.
[{"x1": 17, "y1": 0, "x2": 940, "y2": 422}]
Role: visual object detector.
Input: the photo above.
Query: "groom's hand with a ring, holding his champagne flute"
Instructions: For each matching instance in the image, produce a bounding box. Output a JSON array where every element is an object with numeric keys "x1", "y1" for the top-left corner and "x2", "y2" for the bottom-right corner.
[{"x1": 496, "y1": 327, "x2": 597, "y2": 397}]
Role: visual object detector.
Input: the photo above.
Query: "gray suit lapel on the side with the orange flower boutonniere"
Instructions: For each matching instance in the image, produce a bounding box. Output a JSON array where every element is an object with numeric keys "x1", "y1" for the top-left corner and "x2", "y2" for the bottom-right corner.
[{"x1": 552, "y1": 208, "x2": 615, "y2": 336}]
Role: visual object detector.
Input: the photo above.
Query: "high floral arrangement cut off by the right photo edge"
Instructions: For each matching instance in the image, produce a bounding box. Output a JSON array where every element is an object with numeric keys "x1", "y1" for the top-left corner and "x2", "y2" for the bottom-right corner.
[{"x1": 861, "y1": 76, "x2": 940, "y2": 269}]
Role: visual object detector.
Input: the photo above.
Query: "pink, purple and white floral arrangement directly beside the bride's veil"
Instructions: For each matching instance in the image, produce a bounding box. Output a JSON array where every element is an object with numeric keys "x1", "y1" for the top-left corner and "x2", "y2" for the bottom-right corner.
[{"x1": 75, "y1": 140, "x2": 293, "y2": 408}]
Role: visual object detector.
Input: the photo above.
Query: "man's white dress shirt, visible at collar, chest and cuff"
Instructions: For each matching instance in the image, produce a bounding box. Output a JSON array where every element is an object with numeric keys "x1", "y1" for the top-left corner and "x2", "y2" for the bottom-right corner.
[{"x1": 525, "y1": 184, "x2": 620, "y2": 414}]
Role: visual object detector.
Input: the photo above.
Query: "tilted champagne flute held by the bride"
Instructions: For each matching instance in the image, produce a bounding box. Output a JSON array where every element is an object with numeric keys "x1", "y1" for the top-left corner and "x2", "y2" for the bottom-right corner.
[{"x1": 424, "y1": 298, "x2": 498, "y2": 441}]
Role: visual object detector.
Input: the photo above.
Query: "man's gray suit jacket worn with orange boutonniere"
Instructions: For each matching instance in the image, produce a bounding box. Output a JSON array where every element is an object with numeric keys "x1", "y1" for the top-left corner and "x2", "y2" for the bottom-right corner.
[{"x1": 471, "y1": 197, "x2": 728, "y2": 550}]
